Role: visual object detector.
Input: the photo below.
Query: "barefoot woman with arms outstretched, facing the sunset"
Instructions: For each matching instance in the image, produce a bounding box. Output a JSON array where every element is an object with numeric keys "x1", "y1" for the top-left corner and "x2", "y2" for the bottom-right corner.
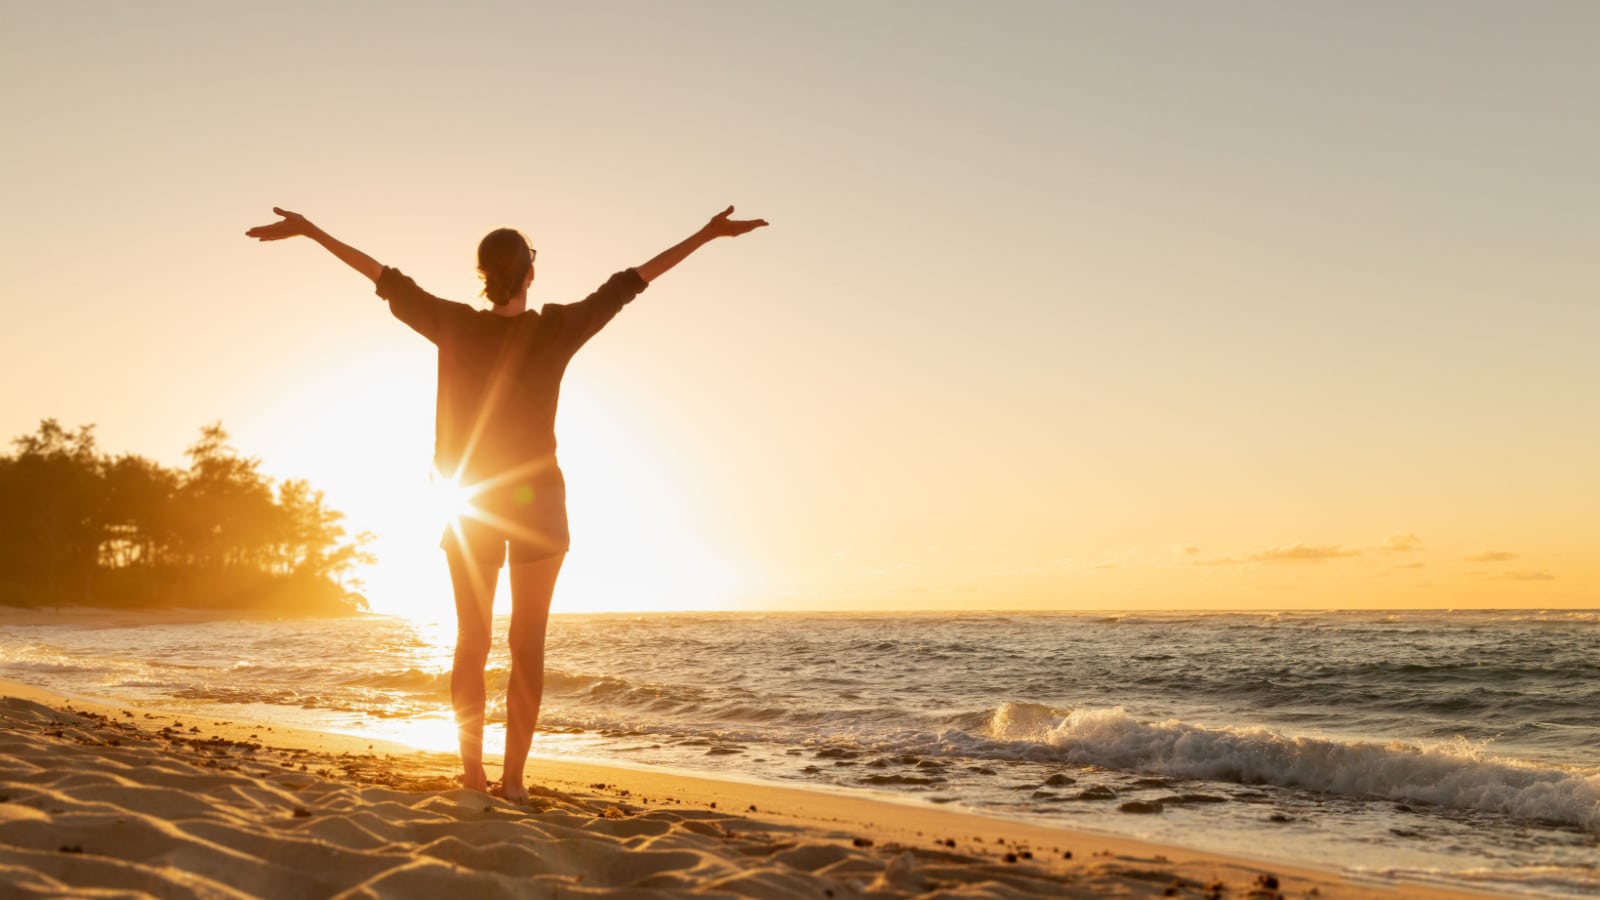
[{"x1": 245, "y1": 207, "x2": 766, "y2": 799}]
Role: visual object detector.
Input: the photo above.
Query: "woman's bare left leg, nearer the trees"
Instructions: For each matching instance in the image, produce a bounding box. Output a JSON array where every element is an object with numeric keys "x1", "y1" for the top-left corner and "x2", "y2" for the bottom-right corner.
[{"x1": 445, "y1": 552, "x2": 499, "y2": 791}]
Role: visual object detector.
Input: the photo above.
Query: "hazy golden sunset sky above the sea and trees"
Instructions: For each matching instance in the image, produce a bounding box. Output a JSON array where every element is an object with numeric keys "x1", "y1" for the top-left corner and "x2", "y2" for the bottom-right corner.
[{"x1": 0, "y1": 0, "x2": 1600, "y2": 615}]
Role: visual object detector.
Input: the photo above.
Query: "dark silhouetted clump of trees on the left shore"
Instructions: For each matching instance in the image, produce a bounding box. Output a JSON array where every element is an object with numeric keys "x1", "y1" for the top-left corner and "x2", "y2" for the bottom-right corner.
[{"x1": 0, "y1": 420, "x2": 371, "y2": 615}]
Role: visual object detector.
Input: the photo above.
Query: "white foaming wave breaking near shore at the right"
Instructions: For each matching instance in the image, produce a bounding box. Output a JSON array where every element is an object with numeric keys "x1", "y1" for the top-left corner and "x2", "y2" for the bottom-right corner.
[{"x1": 989, "y1": 703, "x2": 1600, "y2": 831}]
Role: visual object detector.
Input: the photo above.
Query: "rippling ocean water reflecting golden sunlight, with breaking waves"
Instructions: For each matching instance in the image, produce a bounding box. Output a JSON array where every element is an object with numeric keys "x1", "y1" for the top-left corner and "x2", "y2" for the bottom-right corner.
[{"x1": 0, "y1": 610, "x2": 1600, "y2": 897}]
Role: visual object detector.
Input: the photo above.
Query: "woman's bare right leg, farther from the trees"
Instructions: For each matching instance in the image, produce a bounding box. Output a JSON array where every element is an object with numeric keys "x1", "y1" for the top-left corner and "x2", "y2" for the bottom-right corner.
[{"x1": 501, "y1": 554, "x2": 566, "y2": 799}]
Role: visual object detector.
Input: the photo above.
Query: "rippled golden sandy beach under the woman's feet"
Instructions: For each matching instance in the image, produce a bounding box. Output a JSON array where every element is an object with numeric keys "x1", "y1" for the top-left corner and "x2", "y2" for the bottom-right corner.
[{"x1": 0, "y1": 672, "x2": 1484, "y2": 898}]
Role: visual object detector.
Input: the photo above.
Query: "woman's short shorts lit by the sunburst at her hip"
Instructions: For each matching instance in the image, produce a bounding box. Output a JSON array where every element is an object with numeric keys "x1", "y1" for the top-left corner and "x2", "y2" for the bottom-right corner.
[{"x1": 438, "y1": 472, "x2": 571, "y2": 569}]
